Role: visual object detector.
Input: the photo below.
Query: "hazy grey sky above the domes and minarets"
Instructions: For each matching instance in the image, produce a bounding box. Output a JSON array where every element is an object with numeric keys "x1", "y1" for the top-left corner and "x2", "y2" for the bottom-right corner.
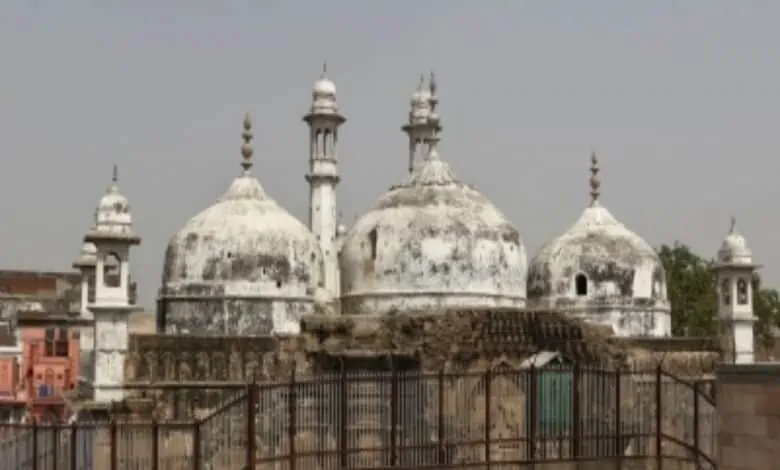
[{"x1": 0, "y1": 0, "x2": 780, "y2": 306}]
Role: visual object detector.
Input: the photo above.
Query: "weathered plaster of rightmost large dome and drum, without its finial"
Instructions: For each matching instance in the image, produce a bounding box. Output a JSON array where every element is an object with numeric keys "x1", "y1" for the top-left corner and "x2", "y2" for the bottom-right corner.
[{"x1": 528, "y1": 201, "x2": 671, "y2": 336}]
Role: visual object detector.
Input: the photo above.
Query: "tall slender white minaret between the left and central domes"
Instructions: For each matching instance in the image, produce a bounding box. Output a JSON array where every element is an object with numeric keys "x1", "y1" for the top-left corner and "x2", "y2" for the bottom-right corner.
[{"x1": 303, "y1": 65, "x2": 346, "y2": 298}]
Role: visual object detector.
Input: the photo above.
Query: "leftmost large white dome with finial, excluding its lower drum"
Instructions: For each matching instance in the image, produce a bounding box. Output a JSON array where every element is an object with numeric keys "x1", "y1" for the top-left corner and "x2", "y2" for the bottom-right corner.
[{"x1": 160, "y1": 117, "x2": 322, "y2": 314}]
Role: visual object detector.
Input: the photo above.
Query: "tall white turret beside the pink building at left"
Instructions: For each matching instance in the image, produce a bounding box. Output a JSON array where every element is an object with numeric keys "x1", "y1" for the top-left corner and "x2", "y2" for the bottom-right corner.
[{"x1": 84, "y1": 166, "x2": 141, "y2": 402}]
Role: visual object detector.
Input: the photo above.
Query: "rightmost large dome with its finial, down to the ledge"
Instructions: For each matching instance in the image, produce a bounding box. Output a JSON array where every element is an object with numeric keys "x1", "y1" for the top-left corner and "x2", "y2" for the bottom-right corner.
[{"x1": 528, "y1": 155, "x2": 666, "y2": 307}]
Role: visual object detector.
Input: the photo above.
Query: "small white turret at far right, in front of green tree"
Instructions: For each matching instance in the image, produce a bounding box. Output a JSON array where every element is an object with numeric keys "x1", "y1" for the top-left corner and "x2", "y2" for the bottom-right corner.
[{"x1": 713, "y1": 217, "x2": 761, "y2": 364}]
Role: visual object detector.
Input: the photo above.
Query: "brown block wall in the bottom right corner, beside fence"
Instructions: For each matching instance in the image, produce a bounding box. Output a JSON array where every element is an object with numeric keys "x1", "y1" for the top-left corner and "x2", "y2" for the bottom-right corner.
[{"x1": 717, "y1": 363, "x2": 780, "y2": 470}]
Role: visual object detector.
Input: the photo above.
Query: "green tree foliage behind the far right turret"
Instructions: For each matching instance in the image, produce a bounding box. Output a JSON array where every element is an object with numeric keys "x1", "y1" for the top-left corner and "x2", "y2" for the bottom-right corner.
[{"x1": 658, "y1": 242, "x2": 780, "y2": 344}]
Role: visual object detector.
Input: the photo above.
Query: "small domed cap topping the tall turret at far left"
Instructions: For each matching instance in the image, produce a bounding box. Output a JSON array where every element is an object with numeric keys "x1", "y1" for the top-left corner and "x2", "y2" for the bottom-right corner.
[{"x1": 84, "y1": 165, "x2": 140, "y2": 243}]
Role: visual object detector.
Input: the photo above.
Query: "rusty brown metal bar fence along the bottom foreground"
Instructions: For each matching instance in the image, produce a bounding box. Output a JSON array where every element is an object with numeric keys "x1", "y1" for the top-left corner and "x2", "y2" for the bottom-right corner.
[{"x1": 0, "y1": 367, "x2": 716, "y2": 470}]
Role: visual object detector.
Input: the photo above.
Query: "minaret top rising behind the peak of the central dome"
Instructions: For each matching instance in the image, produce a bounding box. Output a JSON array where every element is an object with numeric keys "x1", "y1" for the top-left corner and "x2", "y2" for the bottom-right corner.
[{"x1": 401, "y1": 72, "x2": 441, "y2": 173}]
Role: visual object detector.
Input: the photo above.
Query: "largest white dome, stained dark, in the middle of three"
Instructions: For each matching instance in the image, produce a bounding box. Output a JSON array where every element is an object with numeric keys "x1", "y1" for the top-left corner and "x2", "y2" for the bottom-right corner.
[{"x1": 340, "y1": 140, "x2": 526, "y2": 314}]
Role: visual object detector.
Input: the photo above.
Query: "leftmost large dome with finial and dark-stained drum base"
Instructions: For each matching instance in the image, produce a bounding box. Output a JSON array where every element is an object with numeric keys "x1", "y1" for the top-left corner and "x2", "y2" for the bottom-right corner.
[{"x1": 160, "y1": 117, "x2": 322, "y2": 335}]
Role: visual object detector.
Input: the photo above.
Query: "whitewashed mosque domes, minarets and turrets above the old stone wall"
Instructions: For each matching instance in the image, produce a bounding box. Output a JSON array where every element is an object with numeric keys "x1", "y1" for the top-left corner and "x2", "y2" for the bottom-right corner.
[{"x1": 70, "y1": 72, "x2": 758, "y2": 396}]
